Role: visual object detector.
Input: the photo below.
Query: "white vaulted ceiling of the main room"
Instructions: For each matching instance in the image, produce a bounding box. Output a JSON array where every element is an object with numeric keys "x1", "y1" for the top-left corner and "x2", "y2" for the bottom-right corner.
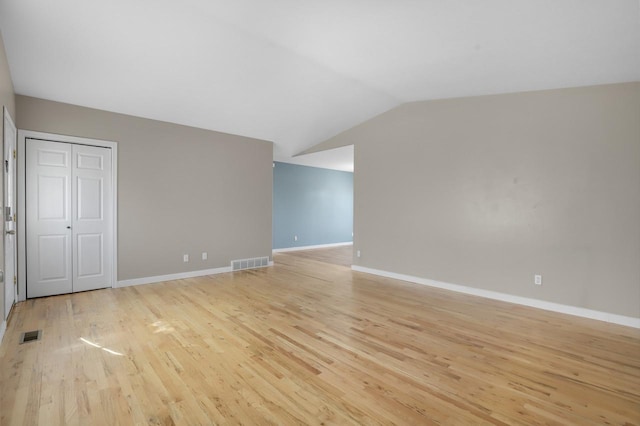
[{"x1": 0, "y1": 0, "x2": 640, "y2": 171}]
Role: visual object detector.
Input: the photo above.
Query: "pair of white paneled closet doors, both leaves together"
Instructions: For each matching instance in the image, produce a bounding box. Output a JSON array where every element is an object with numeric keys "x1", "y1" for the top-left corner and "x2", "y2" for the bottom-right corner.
[{"x1": 25, "y1": 139, "x2": 113, "y2": 298}]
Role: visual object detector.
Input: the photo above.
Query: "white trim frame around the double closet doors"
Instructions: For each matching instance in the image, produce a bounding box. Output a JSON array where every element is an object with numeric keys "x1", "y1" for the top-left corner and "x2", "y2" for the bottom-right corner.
[{"x1": 17, "y1": 130, "x2": 118, "y2": 301}]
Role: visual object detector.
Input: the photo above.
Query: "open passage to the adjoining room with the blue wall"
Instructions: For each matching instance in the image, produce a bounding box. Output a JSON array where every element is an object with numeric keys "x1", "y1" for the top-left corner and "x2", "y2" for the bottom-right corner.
[{"x1": 272, "y1": 146, "x2": 354, "y2": 266}]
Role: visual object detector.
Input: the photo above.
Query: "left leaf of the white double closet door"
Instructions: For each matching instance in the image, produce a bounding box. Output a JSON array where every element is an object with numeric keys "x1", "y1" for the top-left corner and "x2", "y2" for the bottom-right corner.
[{"x1": 25, "y1": 139, "x2": 73, "y2": 297}]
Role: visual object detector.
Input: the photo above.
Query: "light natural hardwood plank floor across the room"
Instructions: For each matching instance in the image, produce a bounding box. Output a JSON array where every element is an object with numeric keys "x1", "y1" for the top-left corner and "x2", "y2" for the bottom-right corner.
[{"x1": 0, "y1": 248, "x2": 640, "y2": 425}]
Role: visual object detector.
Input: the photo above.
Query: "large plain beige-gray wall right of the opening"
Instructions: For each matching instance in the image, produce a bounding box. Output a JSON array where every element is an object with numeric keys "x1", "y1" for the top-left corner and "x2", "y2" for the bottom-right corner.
[{"x1": 328, "y1": 83, "x2": 640, "y2": 317}]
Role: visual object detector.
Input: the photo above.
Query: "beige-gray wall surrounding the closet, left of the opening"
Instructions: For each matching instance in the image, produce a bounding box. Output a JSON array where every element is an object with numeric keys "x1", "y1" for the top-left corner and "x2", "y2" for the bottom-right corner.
[{"x1": 16, "y1": 96, "x2": 273, "y2": 280}]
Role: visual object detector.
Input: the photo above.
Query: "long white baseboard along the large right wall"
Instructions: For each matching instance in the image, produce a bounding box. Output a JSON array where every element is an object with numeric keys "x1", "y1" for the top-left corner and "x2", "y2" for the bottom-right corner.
[{"x1": 351, "y1": 265, "x2": 640, "y2": 328}]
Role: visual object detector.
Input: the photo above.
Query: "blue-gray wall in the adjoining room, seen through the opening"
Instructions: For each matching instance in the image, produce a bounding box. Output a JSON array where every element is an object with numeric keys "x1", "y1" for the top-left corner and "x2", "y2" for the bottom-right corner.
[{"x1": 273, "y1": 162, "x2": 353, "y2": 249}]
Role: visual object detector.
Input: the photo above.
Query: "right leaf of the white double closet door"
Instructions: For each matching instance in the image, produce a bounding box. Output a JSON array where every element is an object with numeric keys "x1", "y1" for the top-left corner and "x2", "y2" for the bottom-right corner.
[{"x1": 72, "y1": 145, "x2": 113, "y2": 291}]
